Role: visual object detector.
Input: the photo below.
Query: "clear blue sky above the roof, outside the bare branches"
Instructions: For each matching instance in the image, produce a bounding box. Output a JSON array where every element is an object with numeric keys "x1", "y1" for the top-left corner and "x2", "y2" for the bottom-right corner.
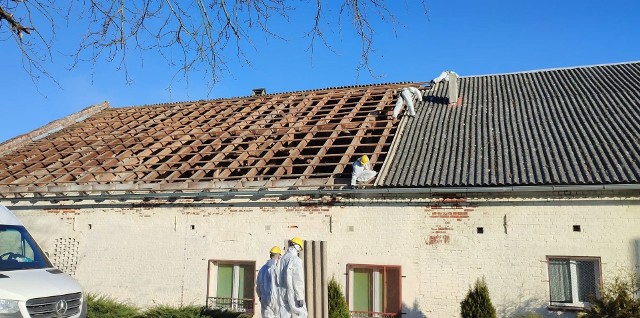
[{"x1": 0, "y1": 0, "x2": 640, "y2": 142}]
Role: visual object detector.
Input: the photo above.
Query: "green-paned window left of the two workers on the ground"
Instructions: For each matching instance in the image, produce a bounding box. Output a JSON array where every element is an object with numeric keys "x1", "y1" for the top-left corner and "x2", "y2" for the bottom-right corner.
[{"x1": 207, "y1": 261, "x2": 256, "y2": 313}]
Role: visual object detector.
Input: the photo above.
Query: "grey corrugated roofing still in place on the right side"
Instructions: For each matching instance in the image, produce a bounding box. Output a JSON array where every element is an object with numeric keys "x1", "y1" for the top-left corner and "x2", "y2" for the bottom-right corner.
[{"x1": 378, "y1": 62, "x2": 640, "y2": 187}]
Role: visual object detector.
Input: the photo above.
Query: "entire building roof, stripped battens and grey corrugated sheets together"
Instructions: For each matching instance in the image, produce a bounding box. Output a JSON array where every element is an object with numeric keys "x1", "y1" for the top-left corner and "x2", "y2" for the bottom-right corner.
[{"x1": 0, "y1": 62, "x2": 640, "y2": 198}]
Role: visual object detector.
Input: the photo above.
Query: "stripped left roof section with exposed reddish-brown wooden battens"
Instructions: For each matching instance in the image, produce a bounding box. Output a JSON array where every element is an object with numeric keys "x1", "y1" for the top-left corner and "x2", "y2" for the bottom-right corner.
[{"x1": 0, "y1": 83, "x2": 420, "y2": 197}]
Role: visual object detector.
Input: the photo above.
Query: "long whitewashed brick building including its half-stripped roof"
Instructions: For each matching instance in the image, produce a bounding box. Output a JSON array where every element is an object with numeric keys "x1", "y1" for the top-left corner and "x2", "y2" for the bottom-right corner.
[{"x1": 0, "y1": 63, "x2": 640, "y2": 318}]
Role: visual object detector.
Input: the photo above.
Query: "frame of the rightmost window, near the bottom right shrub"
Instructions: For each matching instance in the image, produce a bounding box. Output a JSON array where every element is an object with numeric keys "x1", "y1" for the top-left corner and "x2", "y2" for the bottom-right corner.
[{"x1": 546, "y1": 255, "x2": 602, "y2": 311}]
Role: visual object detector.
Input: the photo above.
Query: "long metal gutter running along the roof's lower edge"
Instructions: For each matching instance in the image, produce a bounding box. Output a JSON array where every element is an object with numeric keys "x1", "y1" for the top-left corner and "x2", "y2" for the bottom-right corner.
[{"x1": 0, "y1": 184, "x2": 640, "y2": 203}]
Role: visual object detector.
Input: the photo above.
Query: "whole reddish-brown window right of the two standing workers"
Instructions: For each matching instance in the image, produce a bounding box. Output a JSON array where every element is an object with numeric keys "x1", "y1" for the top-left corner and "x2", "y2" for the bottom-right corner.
[{"x1": 347, "y1": 264, "x2": 402, "y2": 318}]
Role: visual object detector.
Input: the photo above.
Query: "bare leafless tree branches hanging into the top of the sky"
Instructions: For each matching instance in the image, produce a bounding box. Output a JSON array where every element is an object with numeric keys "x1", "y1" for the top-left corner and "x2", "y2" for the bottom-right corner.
[{"x1": 0, "y1": 0, "x2": 427, "y2": 84}]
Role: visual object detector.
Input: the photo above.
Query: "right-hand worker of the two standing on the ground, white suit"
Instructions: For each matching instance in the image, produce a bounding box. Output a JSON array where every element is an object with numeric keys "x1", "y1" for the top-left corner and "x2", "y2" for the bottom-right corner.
[{"x1": 278, "y1": 237, "x2": 308, "y2": 318}]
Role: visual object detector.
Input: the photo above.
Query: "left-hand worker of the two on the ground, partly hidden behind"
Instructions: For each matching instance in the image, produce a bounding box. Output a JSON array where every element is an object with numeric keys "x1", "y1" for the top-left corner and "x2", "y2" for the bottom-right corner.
[{"x1": 256, "y1": 246, "x2": 282, "y2": 318}]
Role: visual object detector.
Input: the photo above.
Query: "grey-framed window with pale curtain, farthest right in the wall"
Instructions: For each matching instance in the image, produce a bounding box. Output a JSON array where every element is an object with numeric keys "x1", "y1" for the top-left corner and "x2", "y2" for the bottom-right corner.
[{"x1": 547, "y1": 257, "x2": 600, "y2": 307}]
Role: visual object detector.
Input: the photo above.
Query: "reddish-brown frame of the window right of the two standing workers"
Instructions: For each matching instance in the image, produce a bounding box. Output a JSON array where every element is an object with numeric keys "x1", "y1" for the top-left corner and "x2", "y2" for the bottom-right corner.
[{"x1": 346, "y1": 263, "x2": 403, "y2": 317}]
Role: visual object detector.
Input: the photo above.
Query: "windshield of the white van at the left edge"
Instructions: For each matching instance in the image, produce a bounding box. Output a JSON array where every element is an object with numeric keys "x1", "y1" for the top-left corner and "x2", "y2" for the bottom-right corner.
[{"x1": 0, "y1": 225, "x2": 52, "y2": 271}]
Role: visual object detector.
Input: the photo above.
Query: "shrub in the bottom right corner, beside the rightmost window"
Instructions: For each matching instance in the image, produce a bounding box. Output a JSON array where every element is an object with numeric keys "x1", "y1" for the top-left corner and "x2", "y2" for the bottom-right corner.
[{"x1": 584, "y1": 273, "x2": 640, "y2": 318}]
